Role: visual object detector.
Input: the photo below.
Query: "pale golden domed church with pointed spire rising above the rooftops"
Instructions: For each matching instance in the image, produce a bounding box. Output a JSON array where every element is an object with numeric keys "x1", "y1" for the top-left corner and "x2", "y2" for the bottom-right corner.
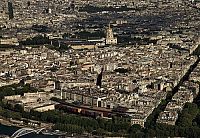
[{"x1": 106, "y1": 24, "x2": 117, "y2": 45}]
